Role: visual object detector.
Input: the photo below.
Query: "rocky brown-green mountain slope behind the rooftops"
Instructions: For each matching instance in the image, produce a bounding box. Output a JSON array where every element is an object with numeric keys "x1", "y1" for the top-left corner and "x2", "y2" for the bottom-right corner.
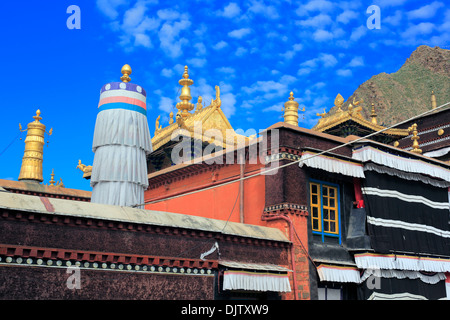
[{"x1": 329, "y1": 45, "x2": 450, "y2": 126}]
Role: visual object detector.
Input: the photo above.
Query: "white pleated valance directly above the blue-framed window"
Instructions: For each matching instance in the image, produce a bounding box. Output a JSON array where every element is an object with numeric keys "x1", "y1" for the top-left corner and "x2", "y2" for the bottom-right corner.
[{"x1": 299, "y1": 151, "x2": 364, "y2": 178}]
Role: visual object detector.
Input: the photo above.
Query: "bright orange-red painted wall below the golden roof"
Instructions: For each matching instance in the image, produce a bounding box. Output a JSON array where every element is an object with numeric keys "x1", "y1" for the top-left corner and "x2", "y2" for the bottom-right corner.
[{"x1": 145, "y1": 164, "x2": 265, "y2": 225}]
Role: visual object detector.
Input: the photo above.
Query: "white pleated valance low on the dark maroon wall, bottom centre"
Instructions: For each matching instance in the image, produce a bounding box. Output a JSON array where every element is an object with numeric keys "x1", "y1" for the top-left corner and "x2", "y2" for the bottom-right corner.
[{"x1": 223, "y1": 270, "x2": 291, "y2": 292}]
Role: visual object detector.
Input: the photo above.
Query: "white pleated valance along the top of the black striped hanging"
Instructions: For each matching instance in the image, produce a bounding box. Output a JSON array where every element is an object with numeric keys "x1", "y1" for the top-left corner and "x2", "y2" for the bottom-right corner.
[{"x1": 352, "y1": 146, "x2": 450, "y2": 181}]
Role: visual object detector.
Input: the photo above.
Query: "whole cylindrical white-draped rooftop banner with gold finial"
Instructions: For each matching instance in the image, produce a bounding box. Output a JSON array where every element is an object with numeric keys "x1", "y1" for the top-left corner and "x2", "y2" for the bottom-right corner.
[{"x1": 91, "y1": 65, "x2": 152, "y2": 208}]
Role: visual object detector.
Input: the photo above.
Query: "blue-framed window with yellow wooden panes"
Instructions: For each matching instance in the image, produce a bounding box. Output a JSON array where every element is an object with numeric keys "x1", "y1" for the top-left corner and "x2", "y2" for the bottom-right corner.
[{"x1": 309, "y1": 181, "x2": 340, "y2": 242}]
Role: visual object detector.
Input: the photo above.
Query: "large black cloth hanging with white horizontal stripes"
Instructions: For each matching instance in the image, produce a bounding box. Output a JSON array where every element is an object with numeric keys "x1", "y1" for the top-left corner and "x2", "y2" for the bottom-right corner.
[{"x1": 362, "y1": 171, "x2": 450, "y2": 256}]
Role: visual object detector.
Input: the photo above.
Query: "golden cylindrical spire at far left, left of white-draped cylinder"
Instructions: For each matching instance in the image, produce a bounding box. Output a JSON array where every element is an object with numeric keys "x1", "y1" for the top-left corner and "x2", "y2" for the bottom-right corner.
[{"x1": 19, "y1": 110, "x2": 53, "y2": 183}]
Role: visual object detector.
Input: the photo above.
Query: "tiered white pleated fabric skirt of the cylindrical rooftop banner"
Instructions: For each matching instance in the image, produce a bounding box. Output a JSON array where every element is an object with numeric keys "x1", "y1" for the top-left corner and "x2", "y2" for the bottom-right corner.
[{"x1": 91, "y1": 109, "x2": 152, "y2": 208}]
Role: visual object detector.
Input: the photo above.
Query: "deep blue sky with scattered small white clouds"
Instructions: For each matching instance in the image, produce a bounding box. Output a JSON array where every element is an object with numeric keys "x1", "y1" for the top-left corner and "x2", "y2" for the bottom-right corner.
[{"x1": 0, "y1": 0, "x2": 450, "y2": 190}]
